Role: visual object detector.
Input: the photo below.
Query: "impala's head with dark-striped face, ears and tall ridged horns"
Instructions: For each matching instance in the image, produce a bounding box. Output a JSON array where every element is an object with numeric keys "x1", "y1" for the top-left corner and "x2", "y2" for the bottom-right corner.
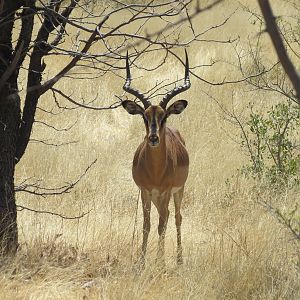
[{"x1": 122, "y1": 52, "x2": 191, "y2": 147}]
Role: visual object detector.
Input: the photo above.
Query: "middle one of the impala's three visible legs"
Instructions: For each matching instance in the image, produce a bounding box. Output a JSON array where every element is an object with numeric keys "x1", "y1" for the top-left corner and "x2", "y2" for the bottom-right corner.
[{"x1": 157, "y1": 193, "x2": 171, "y2": 266}]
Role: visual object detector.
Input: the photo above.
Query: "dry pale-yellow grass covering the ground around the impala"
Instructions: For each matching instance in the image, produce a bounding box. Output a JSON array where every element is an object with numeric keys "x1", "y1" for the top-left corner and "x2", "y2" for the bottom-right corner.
[{"x1": 0, "y1": 1, "x2": 300, "y2": 299}]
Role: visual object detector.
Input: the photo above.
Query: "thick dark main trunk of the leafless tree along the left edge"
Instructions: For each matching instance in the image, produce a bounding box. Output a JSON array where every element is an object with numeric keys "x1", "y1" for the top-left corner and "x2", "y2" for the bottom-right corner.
[{"x1": 0, "y1": 1, "x2": 21, "y2": 254}]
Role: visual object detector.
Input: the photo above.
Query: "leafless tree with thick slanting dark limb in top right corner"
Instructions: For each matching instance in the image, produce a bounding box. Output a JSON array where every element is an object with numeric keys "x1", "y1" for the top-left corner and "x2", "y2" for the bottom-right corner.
[{"x1": 231, "y1": 0, "x2": 300, "y2": 104}]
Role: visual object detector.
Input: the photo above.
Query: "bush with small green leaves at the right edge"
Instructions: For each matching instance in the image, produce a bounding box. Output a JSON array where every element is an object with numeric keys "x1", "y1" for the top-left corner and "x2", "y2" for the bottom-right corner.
[{"x1": 241, "y1": 102, "x2": 300, "y2": 188}]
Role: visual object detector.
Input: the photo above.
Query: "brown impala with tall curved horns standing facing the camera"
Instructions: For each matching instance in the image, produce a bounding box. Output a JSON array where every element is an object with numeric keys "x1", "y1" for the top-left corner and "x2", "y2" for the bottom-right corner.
[{"x1": 122, "y1": 52, "x2": 191, "y2": 267}]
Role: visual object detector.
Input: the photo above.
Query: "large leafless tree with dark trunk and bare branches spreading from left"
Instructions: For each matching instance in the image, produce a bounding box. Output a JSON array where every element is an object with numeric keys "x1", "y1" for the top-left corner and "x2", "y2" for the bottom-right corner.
[{"x1": 0, "y1": 0, "x2": 230, "y2": 253}]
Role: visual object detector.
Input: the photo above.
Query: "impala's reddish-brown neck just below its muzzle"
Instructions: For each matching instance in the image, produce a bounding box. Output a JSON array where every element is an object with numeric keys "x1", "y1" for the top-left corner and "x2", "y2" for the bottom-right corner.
[{"x1": 146, "y1": 128, "x2": 167, "y2": 178}]
